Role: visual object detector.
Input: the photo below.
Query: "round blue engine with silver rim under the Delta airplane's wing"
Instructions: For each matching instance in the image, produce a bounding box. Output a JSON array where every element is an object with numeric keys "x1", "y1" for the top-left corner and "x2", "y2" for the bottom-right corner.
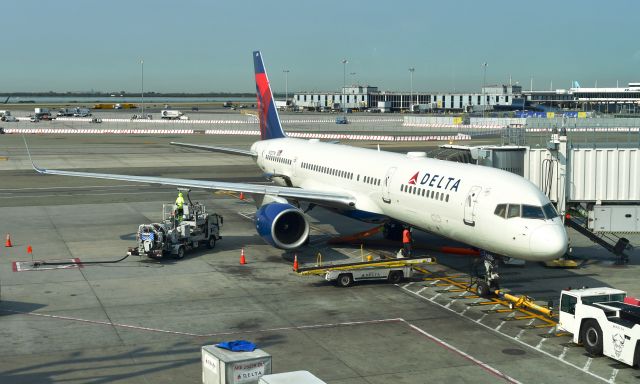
[{"x1": 255, "y1": 203, "x2": 309, "y2": 249}]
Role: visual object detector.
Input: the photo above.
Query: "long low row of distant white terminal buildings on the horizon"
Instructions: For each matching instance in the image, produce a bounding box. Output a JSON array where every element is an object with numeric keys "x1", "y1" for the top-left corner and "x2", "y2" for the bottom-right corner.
[{"x1": 291, "y1": 82, "x2": 640, "y2": 113}]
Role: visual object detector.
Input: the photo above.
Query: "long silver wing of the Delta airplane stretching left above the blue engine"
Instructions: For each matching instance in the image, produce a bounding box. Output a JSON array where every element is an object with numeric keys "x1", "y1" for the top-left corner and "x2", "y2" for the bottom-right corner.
[{"x1": 32, "y1": 162, "x2": 356, "y2": 209}]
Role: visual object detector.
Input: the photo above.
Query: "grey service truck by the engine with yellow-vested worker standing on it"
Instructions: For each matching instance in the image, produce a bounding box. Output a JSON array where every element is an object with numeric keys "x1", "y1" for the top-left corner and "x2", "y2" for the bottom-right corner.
[{"x1": 128, "y1": 191, "x2": 224, "y2": 259}]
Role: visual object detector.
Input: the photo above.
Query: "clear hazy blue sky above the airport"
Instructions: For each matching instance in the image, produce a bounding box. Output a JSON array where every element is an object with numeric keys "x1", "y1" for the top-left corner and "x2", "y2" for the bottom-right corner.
[{"x1": 0, "y1": 0, "x2": 640, "y2": 93}]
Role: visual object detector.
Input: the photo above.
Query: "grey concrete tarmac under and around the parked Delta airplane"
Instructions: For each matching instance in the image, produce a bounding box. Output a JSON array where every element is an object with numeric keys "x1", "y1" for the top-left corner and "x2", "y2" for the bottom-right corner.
[{"x1": 0, "y1": 130, "x2": 640, "y2": 384}]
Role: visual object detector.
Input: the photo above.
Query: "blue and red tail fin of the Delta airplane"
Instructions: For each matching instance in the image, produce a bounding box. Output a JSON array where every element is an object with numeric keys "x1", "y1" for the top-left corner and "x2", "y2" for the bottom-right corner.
[{"x1": 253, "y1": 51, "x2": 287, "y2": 140}]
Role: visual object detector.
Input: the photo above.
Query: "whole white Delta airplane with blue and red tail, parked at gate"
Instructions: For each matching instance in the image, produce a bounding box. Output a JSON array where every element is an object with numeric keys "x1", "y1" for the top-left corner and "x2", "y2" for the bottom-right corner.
[{"x1": 27, "y1": 51, "x2": 568, "y2": 289}]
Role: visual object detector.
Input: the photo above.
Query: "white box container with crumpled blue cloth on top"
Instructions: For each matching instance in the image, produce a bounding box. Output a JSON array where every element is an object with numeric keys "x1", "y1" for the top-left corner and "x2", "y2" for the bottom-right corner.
[{"x1": 202, "y1": 345, "x2": 271, "y2": 384}]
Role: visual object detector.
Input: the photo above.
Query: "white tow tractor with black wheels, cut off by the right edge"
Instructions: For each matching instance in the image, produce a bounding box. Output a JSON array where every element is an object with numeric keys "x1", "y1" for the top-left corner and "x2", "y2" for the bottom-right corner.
[{"x1": 558, "y1": 287, "x2": 640, "y2": 366}]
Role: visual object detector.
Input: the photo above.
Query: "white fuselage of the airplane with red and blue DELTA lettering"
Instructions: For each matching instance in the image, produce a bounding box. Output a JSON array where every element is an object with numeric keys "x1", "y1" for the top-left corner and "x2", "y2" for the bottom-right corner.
[{"x1": 251, "y1": 138, "x2": 567, "y2": 261}]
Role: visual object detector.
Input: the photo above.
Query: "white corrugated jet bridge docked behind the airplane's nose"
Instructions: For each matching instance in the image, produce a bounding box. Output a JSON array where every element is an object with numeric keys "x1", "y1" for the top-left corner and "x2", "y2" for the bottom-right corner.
[{"x1": 434, "y1": 129, "x2": 640, "y2": 262}]
